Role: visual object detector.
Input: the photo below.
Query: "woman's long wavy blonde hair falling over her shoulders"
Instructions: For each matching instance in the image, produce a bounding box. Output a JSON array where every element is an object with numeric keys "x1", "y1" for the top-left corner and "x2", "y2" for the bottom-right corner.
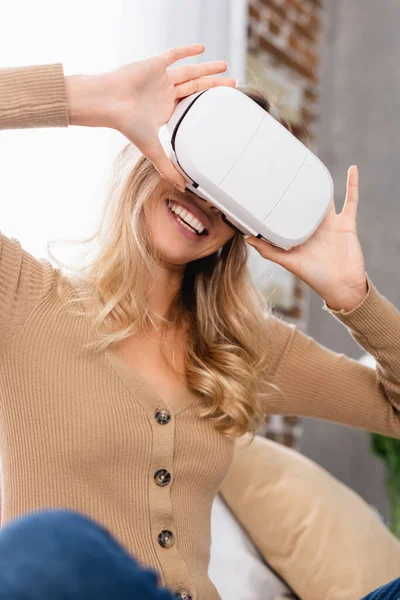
[{"x1": 47, "y1": 87, "x2": 294, "y2": 438}]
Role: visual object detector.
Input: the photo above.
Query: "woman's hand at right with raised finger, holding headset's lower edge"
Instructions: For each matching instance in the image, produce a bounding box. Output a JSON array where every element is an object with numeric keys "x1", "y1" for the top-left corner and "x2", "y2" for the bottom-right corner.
[{"x1": 246, "y1": 165, "x2": 368, "y2": 312}]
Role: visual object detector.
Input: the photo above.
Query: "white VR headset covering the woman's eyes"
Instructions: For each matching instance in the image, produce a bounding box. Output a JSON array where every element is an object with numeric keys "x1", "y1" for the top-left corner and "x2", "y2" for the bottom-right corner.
[{"x1": 159, "y1": 86, "x2": 333, "y2": 250}]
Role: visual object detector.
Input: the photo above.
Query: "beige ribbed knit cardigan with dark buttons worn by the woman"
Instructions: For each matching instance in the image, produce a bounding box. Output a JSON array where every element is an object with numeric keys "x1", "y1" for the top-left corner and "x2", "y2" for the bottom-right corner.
[{"x1": 0, "y1": 63, "x2": 400, "y2": 600}]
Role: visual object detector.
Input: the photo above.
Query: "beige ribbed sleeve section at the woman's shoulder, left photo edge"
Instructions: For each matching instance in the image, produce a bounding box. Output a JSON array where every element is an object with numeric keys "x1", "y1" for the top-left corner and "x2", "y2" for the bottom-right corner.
[{"x1": 0, "y1": 232, "x2": 55, "y2": 347}]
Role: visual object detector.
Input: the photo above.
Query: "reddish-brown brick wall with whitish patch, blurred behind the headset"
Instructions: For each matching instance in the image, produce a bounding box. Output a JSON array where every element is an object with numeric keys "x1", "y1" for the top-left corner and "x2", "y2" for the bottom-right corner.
[{"x1": 247, "y1": 0, "x2": 322, "y2": 448}]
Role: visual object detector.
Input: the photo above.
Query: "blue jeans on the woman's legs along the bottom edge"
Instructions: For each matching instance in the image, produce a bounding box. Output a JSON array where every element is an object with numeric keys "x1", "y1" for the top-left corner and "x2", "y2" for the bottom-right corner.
[{"x1": 0, "y1": 510, "x2": 400, "y2": 600}]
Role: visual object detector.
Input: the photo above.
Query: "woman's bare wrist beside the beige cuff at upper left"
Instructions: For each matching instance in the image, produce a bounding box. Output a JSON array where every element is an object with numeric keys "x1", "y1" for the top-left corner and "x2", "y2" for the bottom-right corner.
[{"x1": 65, "y1": 75, "x2": 111, "y2": 127}]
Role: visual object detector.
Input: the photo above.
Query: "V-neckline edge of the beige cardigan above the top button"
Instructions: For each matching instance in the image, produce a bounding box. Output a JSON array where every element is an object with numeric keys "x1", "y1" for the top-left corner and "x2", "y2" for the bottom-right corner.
[{"x1": 105, "y1": 344, "x2": 197, "y2": 415}]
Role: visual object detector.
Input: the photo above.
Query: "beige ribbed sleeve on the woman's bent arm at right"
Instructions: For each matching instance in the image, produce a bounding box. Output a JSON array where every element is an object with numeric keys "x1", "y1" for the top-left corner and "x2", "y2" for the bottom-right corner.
[{"x1": 267, "y1": 277, "x2": 400, "y2": 438}]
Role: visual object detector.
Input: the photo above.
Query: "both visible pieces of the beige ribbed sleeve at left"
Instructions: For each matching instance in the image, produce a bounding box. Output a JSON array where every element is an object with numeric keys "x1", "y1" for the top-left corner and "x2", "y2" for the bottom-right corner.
[{"x1": 0, "y1": 63, "x2": 69, "y2": 346}]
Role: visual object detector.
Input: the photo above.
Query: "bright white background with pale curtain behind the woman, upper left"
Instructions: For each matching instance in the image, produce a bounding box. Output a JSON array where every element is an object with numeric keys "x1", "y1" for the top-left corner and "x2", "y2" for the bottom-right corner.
[{"x1": 0, "y1": 0, "x2": 247, "y2": 259}]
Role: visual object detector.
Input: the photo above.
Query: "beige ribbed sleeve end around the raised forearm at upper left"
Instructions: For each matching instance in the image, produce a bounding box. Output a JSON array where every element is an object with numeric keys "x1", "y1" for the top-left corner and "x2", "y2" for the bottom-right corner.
[{"x1": 0, "y1": 63, "x2": 69, "y2": 129}]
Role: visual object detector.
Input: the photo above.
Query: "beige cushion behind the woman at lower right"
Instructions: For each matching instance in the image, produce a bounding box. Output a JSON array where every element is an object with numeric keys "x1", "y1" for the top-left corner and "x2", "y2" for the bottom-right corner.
[{"x1": 220, "y1": 436, "x2": 400, "y2": 600}]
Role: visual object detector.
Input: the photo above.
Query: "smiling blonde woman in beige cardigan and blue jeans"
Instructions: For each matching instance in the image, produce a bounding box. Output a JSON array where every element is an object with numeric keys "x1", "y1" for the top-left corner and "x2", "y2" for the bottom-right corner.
[{"x1": 0, "y1": 45, "x2": 400, "y2": 600}]
